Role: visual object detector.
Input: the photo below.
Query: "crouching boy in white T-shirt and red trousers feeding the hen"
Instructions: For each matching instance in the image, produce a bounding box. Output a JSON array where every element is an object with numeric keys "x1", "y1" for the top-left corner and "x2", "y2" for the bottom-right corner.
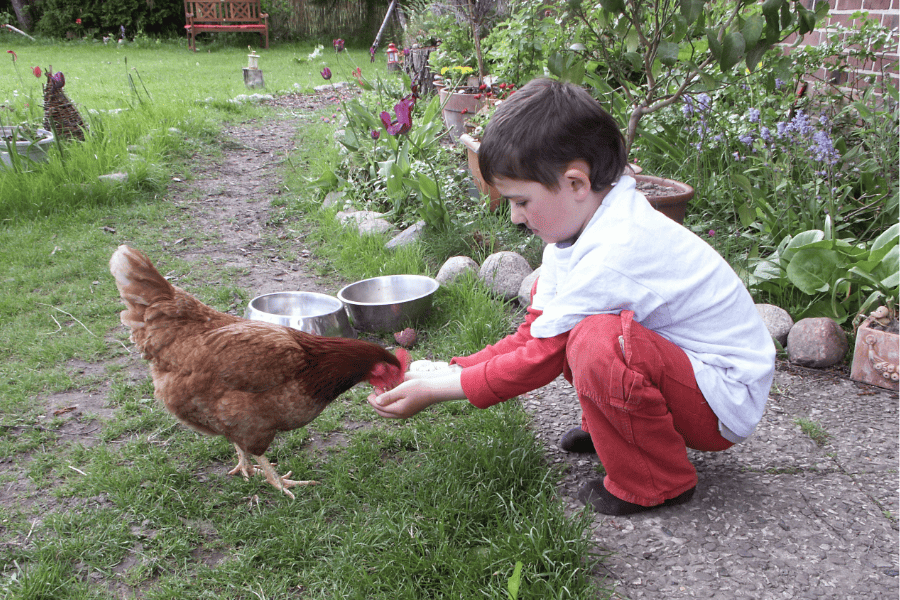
[{"x1": 369, "y1": 79, "x2": 775, "y2": 515}]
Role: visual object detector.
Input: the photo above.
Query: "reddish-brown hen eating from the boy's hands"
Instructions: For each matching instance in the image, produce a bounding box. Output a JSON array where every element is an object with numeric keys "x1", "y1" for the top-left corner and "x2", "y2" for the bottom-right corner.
[{"x1": 109, "y1": 246, "x2": 409, "y2": 498}]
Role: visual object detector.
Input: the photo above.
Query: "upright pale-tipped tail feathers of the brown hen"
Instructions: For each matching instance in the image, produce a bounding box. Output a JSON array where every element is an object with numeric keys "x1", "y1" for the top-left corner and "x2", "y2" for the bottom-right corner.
[{"x1": 109, "y1": 245, "x2": 175, "y2": 329}]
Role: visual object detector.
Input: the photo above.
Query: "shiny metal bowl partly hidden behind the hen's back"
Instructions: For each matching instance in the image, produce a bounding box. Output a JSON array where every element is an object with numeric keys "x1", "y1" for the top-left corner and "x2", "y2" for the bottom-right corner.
[{"x1": 250, "y1": 292, "x2": 356, "y2": 338}]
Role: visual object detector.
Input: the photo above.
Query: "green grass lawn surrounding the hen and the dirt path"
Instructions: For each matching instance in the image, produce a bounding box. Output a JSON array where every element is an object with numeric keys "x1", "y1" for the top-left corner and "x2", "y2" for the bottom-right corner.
[{"x1": 0, "y1": 43, "x2": 607, "y2": 600}]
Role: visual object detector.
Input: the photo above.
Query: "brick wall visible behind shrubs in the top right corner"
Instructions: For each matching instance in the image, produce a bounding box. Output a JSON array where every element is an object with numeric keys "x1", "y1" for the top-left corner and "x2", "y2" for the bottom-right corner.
[{"x1": 785, "y1": 0, "x2": 900, "y2": 87}]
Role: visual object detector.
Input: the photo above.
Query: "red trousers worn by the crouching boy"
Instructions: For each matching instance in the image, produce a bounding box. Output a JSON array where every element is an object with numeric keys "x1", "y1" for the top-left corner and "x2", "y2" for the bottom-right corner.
[{"x1": 563, "y1": 311, "x2": 732, "y2": 506}]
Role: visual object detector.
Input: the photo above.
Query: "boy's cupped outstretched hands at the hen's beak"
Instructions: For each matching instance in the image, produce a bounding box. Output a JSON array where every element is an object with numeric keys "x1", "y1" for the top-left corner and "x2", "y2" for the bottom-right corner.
[{"x1": 368, "y1": 369, "x2": 466, "y2": 419}]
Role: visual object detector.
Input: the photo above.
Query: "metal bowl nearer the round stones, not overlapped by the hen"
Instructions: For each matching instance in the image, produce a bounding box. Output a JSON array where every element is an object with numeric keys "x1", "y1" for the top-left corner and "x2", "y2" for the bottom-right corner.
[{"x1": 338, "y1": 275, "x2": 440, "y2": 331}]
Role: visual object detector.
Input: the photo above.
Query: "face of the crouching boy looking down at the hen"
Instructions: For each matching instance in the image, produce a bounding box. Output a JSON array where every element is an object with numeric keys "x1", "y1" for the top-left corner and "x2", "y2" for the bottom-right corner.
[{"x1": 494, "y1": 163, "x2": 597, "y2": 244}]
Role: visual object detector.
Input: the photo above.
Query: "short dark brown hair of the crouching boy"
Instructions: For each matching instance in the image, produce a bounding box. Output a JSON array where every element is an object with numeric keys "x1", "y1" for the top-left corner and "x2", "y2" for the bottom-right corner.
[{"x1": 478, "y1": 79, "x2": 627, "y2": 192}]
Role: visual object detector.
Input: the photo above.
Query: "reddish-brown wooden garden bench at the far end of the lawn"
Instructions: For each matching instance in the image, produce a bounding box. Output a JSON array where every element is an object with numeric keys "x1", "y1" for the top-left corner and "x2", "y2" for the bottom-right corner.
[{"x1": 184, "y1": 0, "x2": 269, "y2": 52}]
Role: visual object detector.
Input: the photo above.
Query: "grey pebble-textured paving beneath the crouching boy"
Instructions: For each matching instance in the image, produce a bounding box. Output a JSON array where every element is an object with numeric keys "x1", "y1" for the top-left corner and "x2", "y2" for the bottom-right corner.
[{"x1": 521, "y1": 363, "x2": 900, "y2": 600}]
